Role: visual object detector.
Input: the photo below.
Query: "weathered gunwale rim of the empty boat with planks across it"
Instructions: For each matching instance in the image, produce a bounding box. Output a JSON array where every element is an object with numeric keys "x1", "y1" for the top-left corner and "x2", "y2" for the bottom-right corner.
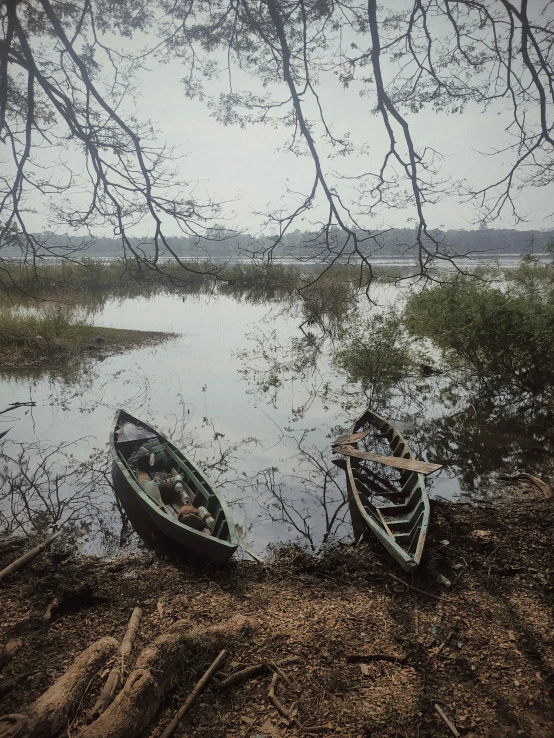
[{"x1": 346, "y1": 409, "x2": 430, "y2": 571}]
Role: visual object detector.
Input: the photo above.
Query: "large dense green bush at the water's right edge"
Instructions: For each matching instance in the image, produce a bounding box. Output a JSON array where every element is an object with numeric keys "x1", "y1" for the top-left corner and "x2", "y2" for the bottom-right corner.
[{"x1": 405, "y1": 262, "x2": 554, "y2": 401}]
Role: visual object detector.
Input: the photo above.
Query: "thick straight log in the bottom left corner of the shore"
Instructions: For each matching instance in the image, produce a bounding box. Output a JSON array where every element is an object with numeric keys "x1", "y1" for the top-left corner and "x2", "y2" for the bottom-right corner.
[{"x1": 0, "y1": 638, "x2": 117, "y2": 738}]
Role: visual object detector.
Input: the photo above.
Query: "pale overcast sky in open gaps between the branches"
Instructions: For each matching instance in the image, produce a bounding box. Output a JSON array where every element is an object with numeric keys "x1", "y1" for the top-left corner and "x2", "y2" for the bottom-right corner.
[{"x1": 25, "y1": 12, "x2": 554, "y2": 235}]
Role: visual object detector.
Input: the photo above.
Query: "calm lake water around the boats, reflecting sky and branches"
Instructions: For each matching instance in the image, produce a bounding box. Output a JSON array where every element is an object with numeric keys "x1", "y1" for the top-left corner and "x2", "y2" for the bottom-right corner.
[{"x1": 0, "y1": 262, "x2": 544, "y2": 554}]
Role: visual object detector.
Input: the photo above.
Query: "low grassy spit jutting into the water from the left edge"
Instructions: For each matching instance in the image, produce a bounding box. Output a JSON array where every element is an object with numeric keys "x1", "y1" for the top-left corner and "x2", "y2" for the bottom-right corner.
[{"x1": 0, "y1": 308, "x2": 168, "y2": 370}]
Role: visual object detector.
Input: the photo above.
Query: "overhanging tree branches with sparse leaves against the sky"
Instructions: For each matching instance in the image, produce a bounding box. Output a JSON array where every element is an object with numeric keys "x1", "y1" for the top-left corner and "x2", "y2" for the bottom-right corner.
[{"x1": 0, "y1": 0, "x2": 554, "y2": 274}]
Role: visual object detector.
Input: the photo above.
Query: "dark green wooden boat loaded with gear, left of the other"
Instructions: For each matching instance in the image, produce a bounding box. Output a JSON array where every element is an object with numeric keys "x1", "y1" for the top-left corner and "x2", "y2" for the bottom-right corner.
[{"x1": 110, "y1": 410, "x2": 238, "y2": 564}]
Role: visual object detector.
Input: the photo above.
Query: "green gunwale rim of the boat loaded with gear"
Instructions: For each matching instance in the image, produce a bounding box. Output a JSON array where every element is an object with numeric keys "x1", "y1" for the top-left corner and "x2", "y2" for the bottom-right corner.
[{"x1": 110, "y1": 408, "x2": 238, "y2": 555}]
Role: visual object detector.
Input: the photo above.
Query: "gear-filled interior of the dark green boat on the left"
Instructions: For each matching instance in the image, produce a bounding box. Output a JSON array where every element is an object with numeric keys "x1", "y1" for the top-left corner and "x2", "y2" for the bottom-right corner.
[{"x1": 114, "y1": 419, "x2": 230, "y2": 541}]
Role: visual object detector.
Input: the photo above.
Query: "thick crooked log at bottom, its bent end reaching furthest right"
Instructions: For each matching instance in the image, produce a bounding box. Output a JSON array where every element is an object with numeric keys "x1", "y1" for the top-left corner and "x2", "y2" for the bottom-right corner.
[{"x1": 77, "y1": 615, "x2": 248, "y2": 738}]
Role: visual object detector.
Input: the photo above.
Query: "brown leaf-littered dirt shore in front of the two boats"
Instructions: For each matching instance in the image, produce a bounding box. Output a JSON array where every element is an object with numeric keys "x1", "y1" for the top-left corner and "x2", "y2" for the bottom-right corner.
[{"x1": 0, "y1": 482, "x2": 554, "y2": 738}]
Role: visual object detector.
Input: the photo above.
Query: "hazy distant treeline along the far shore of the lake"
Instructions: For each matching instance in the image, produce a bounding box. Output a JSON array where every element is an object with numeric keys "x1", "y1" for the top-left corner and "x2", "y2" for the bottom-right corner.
[{"x1": 0, "y1": 228, "x2": 554, "y2": 259}]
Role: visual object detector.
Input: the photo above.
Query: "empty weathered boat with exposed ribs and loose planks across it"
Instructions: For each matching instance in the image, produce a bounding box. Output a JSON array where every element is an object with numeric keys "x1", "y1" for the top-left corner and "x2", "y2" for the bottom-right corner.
[{"x1": 333, "y1": 410, "x2": 441, "y2": 571}]
